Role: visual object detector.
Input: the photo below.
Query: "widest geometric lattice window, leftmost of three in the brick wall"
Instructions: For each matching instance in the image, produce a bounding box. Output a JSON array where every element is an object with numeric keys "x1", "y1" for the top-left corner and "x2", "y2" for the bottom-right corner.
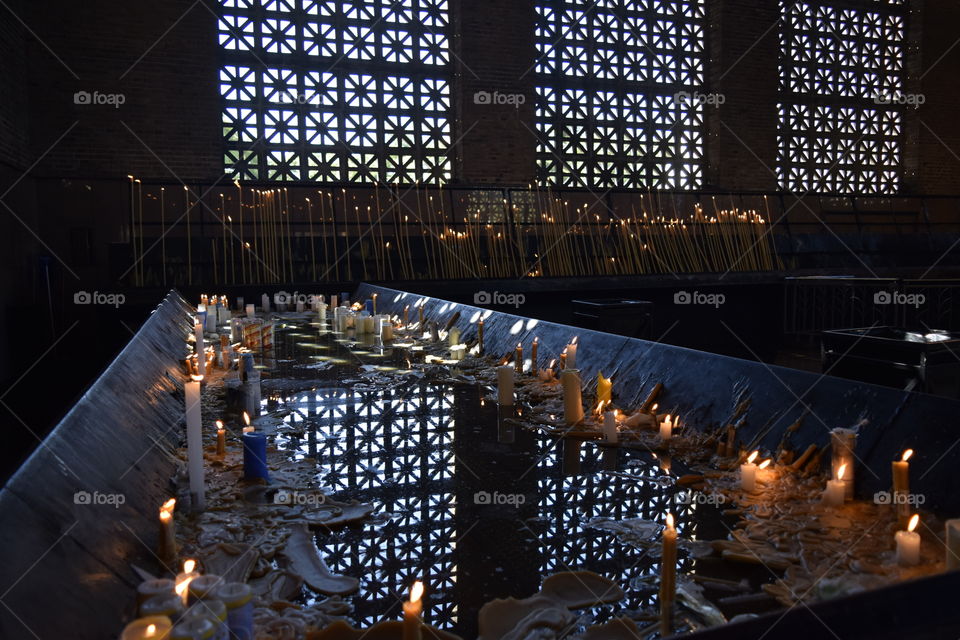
[{"x1": 219, "y1": 0, "x2": 451, "y2": 184}]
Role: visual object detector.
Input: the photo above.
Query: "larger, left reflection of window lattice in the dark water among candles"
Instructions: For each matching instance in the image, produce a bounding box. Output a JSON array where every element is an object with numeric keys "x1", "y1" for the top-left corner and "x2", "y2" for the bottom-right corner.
[{"x1": 286, "y1": 389, "x2": 458, "y2": 628}]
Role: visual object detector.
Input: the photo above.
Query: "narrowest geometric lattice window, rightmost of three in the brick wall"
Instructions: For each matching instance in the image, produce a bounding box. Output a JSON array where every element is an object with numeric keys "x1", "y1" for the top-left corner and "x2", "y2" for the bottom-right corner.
[{"x1": 777, "y1": 0, "x2": 906, "y2": 194}]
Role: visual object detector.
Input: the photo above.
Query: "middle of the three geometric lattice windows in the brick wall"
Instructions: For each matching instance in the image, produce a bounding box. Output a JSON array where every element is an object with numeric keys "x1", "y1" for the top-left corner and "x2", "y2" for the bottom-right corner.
[{"x1": 535, "y1": 0, "x2": 707, "y2": 189}]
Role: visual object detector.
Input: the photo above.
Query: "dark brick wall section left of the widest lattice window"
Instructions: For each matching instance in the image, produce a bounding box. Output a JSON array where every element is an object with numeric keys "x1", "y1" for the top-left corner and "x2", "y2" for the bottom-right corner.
[{"x1": 25, "y1": 0, "x2": 222, "y2": 181}]
